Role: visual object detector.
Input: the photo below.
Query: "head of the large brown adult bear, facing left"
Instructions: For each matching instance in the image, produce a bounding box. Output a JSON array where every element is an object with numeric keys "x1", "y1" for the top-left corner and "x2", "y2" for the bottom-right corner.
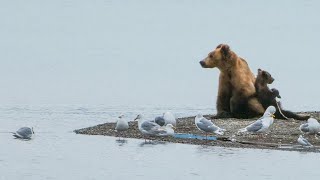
[{"x1": 200, "y1": 44, "x2": 234, "y2": 70}]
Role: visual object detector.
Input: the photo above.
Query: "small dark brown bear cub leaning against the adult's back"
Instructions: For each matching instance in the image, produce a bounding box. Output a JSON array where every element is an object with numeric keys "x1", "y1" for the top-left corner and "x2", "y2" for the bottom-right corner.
[{"x1": 254, "y1": 69, "x2": 310, "y2": 120}]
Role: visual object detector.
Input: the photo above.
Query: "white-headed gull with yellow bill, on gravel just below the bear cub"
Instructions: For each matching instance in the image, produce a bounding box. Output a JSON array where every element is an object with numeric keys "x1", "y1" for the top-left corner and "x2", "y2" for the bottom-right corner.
[{"x1": 238, "y1": 106, "x2": 276, "y2": 133}]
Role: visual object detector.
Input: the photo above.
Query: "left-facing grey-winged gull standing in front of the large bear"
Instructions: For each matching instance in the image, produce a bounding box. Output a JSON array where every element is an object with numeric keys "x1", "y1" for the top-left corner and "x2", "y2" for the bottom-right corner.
[{"x1": 194, "y1": 113, "x2": 226, "y2": 139}]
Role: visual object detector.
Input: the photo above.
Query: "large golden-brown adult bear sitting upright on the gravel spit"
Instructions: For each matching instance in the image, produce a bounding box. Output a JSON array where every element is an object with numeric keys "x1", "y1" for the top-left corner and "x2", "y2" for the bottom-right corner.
[{"x1": 200, "y1": 44, "x2": 264, "y2": 118}]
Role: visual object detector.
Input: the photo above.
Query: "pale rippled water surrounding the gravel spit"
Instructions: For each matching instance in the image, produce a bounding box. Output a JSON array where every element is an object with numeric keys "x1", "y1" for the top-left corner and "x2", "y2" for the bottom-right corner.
[{"x1": 0, "y1": 105, "x2": 320, "y2": 180}]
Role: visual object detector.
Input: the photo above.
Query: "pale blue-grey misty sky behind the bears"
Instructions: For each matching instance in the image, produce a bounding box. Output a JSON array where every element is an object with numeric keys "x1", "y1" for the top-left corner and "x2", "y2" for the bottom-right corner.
[{"x1": 0, "y1": 0, "x2": 320, "y2": 109}]
